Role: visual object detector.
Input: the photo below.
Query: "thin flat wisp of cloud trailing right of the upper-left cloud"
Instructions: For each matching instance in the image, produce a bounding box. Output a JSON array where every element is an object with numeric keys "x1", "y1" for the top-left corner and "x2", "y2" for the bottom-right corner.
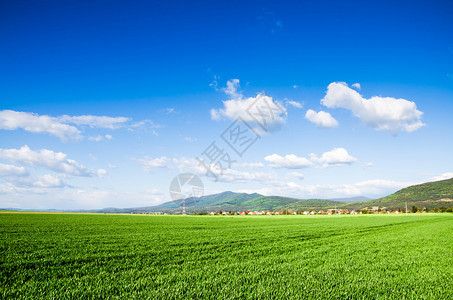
[{"x1": 56, "y1": 115, "x2": 130, "y2": 129}]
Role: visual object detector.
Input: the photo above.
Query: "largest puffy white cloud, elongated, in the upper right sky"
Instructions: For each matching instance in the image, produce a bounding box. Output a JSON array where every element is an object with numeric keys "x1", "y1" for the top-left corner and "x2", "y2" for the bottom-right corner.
[{"x1": 321, "y1": 82, "x2": 425, "y2": 134}]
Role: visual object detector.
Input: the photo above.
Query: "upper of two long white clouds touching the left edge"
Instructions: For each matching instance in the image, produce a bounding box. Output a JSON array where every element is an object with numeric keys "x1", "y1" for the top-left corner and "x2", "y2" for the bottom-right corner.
[{"x1": 0, "y1": 110, "x2": 82, "y2": 140}]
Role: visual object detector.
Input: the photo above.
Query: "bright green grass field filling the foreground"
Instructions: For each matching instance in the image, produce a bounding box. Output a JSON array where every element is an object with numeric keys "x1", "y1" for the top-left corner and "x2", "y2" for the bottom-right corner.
[{"x1": 0, "y1": 213, "x2": 453, "y2": 299}]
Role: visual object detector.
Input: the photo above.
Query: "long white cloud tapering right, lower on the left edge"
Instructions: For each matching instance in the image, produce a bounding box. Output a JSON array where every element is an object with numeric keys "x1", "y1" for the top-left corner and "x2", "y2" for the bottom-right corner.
[{"x1": 0, "y1": 145, "x2": 105, "y2": 176}]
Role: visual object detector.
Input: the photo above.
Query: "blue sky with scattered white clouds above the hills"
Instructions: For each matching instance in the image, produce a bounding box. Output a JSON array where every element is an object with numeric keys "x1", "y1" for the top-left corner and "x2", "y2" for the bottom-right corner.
[{"x1": 0, "y1": 1, "x2": 453, "y2": 209}]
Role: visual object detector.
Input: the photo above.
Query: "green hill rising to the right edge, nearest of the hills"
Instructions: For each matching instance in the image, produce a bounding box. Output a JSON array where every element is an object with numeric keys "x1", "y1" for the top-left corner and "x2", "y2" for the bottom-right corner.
[{"x1": 344, "y1": 178, "x2": 453, "y2": 209}]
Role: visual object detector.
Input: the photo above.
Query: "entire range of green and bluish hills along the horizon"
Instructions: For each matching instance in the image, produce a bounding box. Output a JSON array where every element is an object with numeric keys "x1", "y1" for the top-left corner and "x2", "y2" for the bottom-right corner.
[{"x1": 85, "y1": 178, "x2": 453, "y2": 213}]
